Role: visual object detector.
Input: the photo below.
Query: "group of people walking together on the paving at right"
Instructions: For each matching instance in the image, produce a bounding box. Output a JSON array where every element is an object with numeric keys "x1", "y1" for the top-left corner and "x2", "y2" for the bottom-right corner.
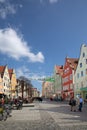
[{"x1": 69, "y1": 95, "x2": 83, "y2": 112}]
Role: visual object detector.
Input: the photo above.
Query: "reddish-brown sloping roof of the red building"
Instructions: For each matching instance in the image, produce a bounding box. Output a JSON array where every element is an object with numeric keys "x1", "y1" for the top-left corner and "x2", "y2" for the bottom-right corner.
[{"x1": 66, "y1": 58, "x2": 79, "y2": 70}]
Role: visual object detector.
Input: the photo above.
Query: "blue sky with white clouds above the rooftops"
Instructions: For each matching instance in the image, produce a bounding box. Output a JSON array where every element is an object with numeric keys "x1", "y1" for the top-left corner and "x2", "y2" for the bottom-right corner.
[{"x1": 0, "y1": 0, "x2": 87, "y2": 91}]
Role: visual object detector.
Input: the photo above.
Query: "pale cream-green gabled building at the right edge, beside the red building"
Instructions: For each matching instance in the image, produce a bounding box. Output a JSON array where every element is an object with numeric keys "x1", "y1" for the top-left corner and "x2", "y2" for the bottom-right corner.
[{"x1": 74, "y1": 44, "x2": 87, "y2": 99}]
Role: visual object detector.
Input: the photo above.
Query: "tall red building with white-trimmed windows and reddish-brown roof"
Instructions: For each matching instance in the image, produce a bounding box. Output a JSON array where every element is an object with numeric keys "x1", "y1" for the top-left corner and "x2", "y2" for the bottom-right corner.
[{"x1": 62, "y1": 58, "x2": 78, "y2": 100}]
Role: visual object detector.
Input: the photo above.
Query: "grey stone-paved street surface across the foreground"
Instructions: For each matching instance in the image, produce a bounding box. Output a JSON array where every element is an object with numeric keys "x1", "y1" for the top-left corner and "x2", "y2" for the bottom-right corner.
[{"x1": 0, "y1": 101, "x2": 87, "y2": 130}]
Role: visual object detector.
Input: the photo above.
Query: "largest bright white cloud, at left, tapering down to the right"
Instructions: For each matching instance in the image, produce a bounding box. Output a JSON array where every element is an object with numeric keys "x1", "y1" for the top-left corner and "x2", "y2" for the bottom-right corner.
[{"x1": 0, "y1": 28, "x2": 44, "y2": 62}]
